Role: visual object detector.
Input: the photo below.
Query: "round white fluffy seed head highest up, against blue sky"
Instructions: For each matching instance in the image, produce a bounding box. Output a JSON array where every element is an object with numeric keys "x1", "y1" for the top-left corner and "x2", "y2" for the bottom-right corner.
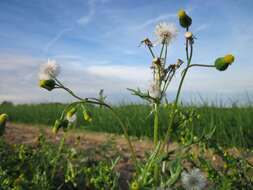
[{"x1": 155, "y1": 22, "x2": 178, "y2": 44}]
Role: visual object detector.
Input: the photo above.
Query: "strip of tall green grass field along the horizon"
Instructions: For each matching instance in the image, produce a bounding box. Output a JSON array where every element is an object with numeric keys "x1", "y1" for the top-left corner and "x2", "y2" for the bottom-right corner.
[{"x1": 0, "y1": 101, "x2": 253, "y2": 148}]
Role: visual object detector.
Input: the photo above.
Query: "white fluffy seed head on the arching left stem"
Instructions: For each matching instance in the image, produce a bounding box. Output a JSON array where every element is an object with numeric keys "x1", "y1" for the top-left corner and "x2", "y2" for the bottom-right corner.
[{"x1": 39, "y1": 59, "x2": 60, "y2": 80}]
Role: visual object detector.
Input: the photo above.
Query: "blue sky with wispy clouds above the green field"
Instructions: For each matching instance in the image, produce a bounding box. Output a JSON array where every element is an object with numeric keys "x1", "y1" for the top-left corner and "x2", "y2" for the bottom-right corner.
[{"x1": 0, "y1": 0, "x2": 253, "y2": 103}]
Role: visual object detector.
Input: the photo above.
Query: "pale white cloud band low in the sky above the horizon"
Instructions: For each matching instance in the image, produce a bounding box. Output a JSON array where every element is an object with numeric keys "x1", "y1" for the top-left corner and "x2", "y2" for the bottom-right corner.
[{"x1": 0, "y1": 54, "x2": 253, "y2": 103}]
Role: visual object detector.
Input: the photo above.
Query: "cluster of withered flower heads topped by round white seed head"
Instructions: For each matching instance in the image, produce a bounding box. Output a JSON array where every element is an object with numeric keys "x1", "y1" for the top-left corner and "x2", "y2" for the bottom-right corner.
[{"x1": 129, "y1": 22, "x2": 181, "y2": 104}]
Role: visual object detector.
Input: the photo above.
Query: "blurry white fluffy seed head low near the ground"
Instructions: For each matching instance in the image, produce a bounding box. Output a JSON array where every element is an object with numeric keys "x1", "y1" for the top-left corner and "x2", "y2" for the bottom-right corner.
[{"x1": 181, "y1": 168, "x2": 206, "y2": 190}]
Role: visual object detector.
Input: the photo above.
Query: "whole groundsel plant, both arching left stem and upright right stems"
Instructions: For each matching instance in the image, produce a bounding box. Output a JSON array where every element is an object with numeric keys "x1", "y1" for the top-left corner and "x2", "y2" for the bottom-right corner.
[{"x1": 39, "y1": 10, "x2": 237, "y2": 190}]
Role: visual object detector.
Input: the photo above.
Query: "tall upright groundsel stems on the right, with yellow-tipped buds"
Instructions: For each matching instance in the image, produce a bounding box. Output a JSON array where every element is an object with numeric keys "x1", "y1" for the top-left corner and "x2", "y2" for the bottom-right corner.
[{"x1": 128, "y1": 10, "x2": 234, "y2": 189}]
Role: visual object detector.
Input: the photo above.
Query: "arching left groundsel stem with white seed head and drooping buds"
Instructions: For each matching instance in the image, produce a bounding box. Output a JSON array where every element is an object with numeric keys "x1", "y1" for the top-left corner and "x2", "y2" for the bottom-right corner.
[{"x1": 39, "y1": 60, "x2": 137, "y2": 164}]
